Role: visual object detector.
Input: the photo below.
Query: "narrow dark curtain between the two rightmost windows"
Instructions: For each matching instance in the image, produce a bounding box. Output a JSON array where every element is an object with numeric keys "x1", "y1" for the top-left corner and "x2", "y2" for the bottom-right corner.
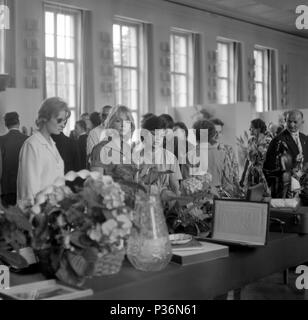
[{"x1": 233, "y1": 42, "x2": 243, "y2": 102}]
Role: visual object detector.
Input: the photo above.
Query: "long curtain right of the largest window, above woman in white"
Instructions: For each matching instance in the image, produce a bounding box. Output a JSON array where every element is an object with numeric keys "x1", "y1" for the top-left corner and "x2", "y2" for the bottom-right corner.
[{"x1": 78, "y1": 11, "x2": 94, "y2": 114}]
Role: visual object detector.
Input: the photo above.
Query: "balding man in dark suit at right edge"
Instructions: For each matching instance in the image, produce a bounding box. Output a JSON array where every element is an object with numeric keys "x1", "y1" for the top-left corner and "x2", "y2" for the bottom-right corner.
[{"x1": 263, "y1": 110, "x2": 308, "y2": 198}]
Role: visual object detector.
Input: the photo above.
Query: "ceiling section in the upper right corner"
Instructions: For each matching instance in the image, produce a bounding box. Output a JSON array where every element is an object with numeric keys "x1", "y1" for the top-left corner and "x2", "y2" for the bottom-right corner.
[{"x1": 165, "y1": 0, "x2": 308, "y2": 38}]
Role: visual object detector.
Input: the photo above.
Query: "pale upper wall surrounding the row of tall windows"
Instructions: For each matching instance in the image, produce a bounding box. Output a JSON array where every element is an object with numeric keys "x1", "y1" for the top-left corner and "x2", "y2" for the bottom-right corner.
[{"x1": 0, "y1": 0, "x2": 308, "y2": 130}]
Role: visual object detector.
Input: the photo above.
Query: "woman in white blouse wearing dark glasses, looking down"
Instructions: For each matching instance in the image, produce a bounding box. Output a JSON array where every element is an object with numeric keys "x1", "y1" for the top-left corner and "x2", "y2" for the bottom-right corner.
[{"x1": 17, "y1": 97, "x2": 71, "y2": 207}]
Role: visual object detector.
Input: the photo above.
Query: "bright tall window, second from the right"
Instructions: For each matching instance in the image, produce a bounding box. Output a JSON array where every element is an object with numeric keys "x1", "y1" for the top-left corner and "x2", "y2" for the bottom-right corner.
[{"x1": 217, "y1": 41, "x2": 235, "y2": 104}]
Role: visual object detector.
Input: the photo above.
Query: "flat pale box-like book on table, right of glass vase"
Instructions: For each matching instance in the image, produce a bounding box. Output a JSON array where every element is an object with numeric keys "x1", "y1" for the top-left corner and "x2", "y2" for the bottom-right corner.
[{"x1": 172, "y1": 239, "x2": 229, "y2": 266}]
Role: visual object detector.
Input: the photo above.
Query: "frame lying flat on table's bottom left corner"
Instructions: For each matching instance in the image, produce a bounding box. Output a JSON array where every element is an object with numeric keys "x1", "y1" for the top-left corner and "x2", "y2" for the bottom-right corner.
[{"x1": 0, "y1": 280, "x2": 93, "y2": 300}]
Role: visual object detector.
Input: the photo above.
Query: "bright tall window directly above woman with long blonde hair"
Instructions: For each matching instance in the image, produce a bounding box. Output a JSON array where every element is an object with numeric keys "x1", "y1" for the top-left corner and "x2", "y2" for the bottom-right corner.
[{"x1": 113, "y1": 21, "x2": 142, "y2": 124}]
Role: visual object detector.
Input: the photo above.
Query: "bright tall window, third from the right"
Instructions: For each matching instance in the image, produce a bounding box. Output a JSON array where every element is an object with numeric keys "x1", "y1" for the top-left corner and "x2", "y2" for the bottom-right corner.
[{"x1": 170, "y1": 31, "x2": 192, "y2": 107}]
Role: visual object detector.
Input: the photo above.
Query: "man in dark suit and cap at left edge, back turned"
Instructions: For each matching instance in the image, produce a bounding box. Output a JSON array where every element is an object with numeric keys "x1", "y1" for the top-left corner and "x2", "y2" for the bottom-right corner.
[{"x1": 0, "y1": 112, "x2": 28, "y2": 207}]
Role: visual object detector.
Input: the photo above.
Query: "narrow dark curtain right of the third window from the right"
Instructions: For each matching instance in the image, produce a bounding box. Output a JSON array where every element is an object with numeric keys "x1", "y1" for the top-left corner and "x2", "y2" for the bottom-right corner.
[{"x1": 192, "y1": 33, "x2": 203, "y2": 106}]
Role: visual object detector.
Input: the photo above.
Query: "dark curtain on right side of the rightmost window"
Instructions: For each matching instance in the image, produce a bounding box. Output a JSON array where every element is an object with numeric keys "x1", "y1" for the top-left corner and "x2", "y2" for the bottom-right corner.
[{"x1": 267, "y1": 49, "x2": 278, "y2": 110}]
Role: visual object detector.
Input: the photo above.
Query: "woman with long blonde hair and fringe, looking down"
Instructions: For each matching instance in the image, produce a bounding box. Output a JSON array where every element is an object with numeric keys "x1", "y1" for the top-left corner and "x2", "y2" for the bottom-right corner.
[{"x1": 90, "y1": 105, "x2": 135, "y2": 174}]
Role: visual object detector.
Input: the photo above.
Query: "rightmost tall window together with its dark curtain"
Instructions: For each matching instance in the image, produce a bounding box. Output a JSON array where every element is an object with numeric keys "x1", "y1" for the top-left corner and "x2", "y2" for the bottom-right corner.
[{"x1": 254, "y1": 46, "x2": 277, "y2": 112}]
